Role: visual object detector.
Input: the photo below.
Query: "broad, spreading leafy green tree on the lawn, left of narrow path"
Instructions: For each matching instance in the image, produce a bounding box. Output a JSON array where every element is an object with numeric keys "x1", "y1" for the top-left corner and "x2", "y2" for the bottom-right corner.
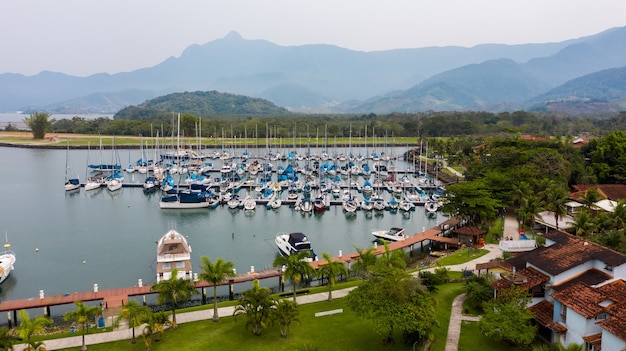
[{"x1": 346, "y1": 265, "x2": 437, "y2": 342}]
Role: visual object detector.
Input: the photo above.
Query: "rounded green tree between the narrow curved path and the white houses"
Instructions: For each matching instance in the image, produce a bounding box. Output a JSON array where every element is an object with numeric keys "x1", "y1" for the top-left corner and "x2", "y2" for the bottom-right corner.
[{"x1": 478, "y1": 287, "x2": 537, "y2": 345}]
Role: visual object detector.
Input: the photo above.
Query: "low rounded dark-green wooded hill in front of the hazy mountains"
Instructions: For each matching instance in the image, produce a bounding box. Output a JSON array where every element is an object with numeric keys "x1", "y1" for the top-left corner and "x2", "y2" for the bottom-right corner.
[{"x1": 113, "y1": 91, "x2": 289, "y2": 119}]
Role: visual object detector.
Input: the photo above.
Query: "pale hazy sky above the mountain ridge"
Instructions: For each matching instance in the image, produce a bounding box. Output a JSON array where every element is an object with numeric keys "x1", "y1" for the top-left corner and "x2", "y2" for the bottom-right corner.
[{"x1": 0, "y1": 0, "x2": 626, "y2": 76}]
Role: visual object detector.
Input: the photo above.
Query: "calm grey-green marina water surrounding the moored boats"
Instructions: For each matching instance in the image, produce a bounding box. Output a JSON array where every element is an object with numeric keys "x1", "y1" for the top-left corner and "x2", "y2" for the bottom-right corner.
[{"x1": 0, "y1": 147, "x2": 444, "y2": 314}]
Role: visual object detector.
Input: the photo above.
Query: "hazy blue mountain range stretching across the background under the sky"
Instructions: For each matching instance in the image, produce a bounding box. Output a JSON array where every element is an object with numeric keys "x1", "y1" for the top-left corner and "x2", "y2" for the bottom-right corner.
[{"x1": 0, "y1": 27, "x2": 626, "y2": 113}]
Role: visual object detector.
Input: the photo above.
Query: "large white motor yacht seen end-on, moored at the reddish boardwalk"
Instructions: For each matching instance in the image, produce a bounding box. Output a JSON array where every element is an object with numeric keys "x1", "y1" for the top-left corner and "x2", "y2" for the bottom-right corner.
[{"x1": 156, "y1": 229, "x2": 193, "y2": 283}]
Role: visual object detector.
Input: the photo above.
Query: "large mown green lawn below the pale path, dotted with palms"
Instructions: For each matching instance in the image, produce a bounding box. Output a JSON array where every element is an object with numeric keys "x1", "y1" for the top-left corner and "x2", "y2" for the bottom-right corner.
[{"x1": 57, "y1": 299, "x2": 408, "y2": 351}]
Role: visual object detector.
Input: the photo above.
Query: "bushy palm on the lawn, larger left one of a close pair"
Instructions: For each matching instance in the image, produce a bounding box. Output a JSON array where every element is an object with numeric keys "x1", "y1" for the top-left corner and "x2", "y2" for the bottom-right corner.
[{"x1": 233, "y1": 280, "x2": 275, "y2": 336}]
